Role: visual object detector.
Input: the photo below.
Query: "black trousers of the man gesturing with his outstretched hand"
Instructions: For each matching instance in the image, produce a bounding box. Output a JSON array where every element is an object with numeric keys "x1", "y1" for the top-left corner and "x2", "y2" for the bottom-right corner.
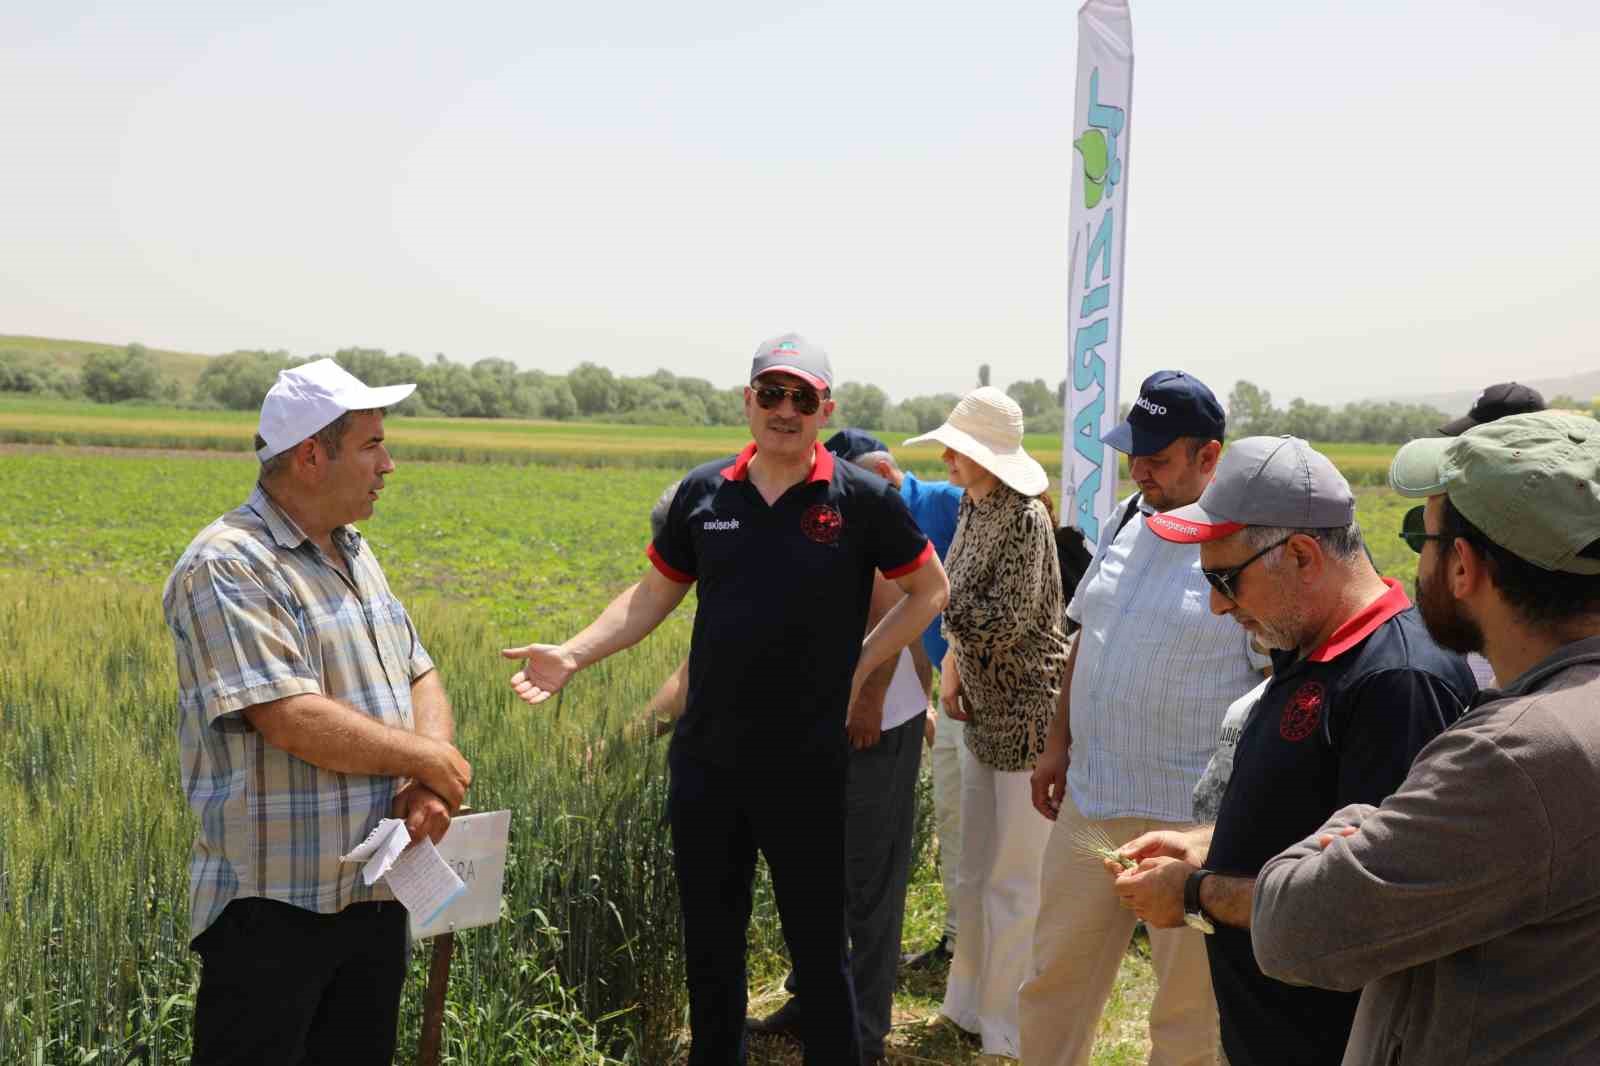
[{"x1": 667, "y1": 744, "x2": 861, "y2": 1066}]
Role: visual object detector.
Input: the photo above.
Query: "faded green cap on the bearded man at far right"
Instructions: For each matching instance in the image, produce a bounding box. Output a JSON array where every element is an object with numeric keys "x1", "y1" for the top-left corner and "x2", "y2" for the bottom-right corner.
[{"x1": 1389, "y1": 411, "x2": 1600, "y2": 573}]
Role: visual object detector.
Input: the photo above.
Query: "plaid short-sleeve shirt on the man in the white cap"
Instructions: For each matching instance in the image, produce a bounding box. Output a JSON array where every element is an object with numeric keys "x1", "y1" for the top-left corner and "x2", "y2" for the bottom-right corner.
[{"x1": 162, "y1": 485, "x2": 434, "y2": 938}]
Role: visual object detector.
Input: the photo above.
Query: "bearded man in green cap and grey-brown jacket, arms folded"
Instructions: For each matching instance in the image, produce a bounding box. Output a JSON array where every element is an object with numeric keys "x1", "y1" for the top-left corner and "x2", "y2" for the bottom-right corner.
[{"x1": 1251, "y1": 411, "x2": 1600, "y2": 1066}]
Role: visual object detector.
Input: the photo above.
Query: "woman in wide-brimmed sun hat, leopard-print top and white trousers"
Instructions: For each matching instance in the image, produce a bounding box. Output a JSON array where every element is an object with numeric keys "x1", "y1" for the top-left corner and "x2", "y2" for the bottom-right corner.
[{"x1": 906, "y1": 386, "x2": 1067, "y2": 1058}]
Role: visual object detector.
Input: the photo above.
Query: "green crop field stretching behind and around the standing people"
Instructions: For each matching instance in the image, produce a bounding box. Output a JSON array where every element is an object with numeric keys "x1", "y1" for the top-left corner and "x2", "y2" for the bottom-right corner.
[{"x1": 0, "y1": 416, "x2": 1414, "y2": 1066}]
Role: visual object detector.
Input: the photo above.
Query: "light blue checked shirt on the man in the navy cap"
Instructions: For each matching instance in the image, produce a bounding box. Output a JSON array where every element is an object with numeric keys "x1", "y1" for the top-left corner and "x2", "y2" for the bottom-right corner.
[{"x1": 1067, "y1": 501, "x2": 1270, "y2": 823}]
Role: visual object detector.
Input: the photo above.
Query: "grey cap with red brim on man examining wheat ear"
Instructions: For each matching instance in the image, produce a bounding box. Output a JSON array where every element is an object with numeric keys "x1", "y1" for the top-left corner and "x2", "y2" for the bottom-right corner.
[{"x1": 1146, "y1": 437, "x2": 1355, "y2": 544}]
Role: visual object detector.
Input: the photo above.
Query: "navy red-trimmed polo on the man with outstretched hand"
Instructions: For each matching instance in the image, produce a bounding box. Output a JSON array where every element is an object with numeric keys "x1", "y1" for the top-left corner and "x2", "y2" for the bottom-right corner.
[{"x1": 648, "y1": 443, "x2": 933, "y2": 767}]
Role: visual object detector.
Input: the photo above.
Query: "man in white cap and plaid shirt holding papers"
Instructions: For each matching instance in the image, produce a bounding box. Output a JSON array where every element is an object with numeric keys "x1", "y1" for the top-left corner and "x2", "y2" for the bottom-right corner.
[{"x1": 162, "y1": 359, "x2": 472, "y2": 1066}]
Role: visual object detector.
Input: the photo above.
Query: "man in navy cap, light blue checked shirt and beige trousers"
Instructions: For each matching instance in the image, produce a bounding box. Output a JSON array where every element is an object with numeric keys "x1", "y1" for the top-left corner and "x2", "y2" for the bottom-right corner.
[{"x1": 1019, "y1": 370, "x2": 1267, "y2": 1066}]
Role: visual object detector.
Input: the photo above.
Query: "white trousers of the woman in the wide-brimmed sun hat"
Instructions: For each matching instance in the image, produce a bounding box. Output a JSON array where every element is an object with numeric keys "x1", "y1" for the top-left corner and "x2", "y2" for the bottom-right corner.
[{"x1": 944, "y1": 744, "x2": 1050, "y2": 1058}]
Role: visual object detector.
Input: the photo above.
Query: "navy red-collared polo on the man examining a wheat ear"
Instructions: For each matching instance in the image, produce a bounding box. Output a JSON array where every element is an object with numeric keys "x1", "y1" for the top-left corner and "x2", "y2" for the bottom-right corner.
[{"x1": 1206, "y1": 578, "x2": 1477, "y2": 1066}]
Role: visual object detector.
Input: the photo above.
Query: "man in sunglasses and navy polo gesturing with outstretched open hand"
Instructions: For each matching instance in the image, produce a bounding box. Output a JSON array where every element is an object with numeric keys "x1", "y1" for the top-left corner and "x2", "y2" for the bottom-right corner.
[{"x1": 504, "y1": 333, "x2": 949, "y2": 1066}]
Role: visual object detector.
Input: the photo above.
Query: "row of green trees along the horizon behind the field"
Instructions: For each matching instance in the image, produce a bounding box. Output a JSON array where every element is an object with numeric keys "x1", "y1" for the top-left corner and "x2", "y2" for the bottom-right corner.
[{"x1": 0, "y1": 344, "x2": 1600, "y2": 443}]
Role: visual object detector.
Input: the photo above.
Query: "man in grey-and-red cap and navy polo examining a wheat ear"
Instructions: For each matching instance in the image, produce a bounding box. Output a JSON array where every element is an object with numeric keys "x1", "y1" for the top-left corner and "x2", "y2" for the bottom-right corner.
[{"x1": 1107, "y1": 437, "x2": 1477, "y2": 1066}]
